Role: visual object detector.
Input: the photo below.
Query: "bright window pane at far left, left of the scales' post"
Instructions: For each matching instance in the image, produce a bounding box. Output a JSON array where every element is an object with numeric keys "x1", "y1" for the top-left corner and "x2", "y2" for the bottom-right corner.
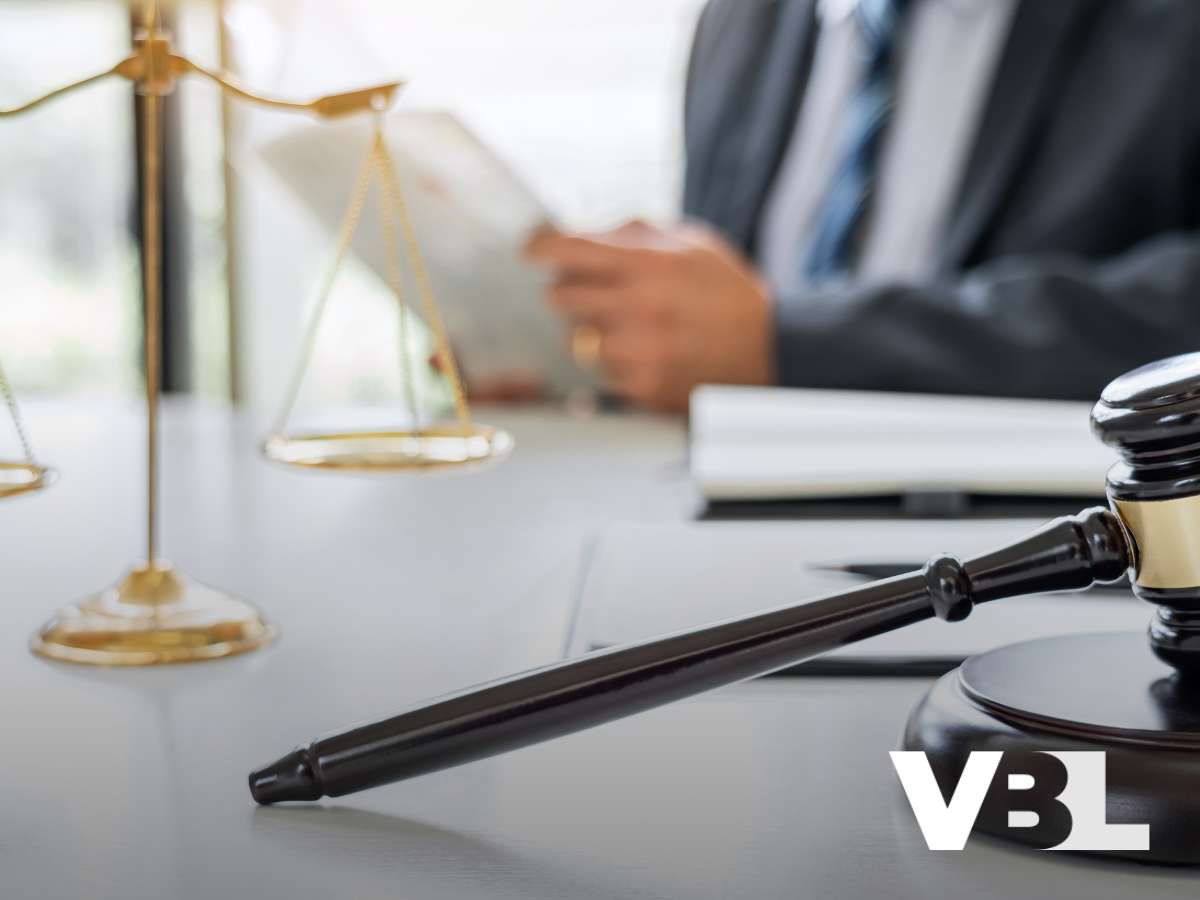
[{"x1": 0, "y1": 0, "x2": 140, "y2": 395}]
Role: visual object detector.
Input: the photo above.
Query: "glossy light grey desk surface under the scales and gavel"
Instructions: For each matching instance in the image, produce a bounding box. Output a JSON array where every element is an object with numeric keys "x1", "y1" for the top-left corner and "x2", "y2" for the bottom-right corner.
[{"x1": 0, "y1": 407, "x2": 1196, "y2": 900}]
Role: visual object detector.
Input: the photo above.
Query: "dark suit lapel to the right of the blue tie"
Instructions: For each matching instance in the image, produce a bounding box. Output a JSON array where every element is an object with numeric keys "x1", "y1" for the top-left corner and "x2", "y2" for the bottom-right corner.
[{"x1": 940, "y1": 0, "x2": 1096, "y2": 271}]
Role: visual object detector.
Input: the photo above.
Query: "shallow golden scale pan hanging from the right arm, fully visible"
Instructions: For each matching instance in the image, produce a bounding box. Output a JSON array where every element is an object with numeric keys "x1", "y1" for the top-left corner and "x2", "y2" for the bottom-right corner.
[{"x1": 263, "y1": 425, "x2": 512, "y2": 472}]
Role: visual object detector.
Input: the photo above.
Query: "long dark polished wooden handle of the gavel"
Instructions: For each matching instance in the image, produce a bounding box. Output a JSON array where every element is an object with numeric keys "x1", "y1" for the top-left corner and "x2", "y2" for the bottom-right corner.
[{"x1": 251, "y1": 508, "x2": 1133, "y2": 803}]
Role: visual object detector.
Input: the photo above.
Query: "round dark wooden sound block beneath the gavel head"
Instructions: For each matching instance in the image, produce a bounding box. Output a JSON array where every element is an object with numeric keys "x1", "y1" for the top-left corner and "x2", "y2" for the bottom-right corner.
[{"x1": 902, "y1": 634, "x2": 1200, "y2": 864}]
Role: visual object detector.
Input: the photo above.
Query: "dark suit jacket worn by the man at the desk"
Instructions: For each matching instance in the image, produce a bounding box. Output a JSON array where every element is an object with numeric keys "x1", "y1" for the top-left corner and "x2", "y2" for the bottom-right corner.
[{"x1": 684, "y1": 0, "x2": 1200, "y2": 400}]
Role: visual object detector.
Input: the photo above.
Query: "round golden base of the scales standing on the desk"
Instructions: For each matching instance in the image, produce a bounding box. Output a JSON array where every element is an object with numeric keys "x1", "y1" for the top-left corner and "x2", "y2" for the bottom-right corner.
[{"x1": 30, "y1": 560, "x2": 276, "y2": 666}]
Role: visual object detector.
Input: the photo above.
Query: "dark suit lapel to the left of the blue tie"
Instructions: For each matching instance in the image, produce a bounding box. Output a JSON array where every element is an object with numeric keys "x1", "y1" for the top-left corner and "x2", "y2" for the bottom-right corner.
[{"x1": 706, "y1": 0, "x2": 816, "y2": 250}]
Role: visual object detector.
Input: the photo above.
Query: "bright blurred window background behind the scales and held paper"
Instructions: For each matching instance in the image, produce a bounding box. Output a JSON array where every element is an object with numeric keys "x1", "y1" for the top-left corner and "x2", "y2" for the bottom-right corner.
[{"x1": 0, "y1": 0, "x2": 701, "y2": 422}]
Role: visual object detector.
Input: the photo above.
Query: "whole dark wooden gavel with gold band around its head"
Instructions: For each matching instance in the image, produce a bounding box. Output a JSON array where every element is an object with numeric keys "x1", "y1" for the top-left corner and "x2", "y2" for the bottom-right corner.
[{"x1": 250, "y1": 353, "x2": 1200, "y2": 804}]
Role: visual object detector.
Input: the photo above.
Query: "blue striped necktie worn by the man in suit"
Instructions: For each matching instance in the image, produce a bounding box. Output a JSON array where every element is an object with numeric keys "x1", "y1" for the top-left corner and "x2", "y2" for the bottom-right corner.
[{"x1": 804, "y1": 0, "x2": 910, "y2": 283}]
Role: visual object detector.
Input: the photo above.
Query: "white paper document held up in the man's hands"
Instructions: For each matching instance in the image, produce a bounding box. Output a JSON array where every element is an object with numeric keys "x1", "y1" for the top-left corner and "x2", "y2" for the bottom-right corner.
[{"x1": 262, "y1": 110, "x2": 588, "y2": 394}]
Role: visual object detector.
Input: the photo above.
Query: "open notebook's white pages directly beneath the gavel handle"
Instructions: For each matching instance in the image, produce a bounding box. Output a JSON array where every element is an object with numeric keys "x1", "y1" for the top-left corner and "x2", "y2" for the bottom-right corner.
[{"x1": 566, "y1": 520, "x2": 1151, "y2": 674}]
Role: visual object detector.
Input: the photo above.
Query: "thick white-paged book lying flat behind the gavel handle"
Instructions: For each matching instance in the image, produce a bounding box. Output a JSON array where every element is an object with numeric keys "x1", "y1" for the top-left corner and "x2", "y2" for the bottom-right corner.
[{"x1": 691, "y1": 385, "x2": 1117, "y2": 500}]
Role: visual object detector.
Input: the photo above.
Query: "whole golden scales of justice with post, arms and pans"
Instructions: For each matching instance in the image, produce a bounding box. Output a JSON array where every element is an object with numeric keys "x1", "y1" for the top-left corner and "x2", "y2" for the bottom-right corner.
[{"x1": 0, "y1": 0, "x2": 512, "y2": 666}]
